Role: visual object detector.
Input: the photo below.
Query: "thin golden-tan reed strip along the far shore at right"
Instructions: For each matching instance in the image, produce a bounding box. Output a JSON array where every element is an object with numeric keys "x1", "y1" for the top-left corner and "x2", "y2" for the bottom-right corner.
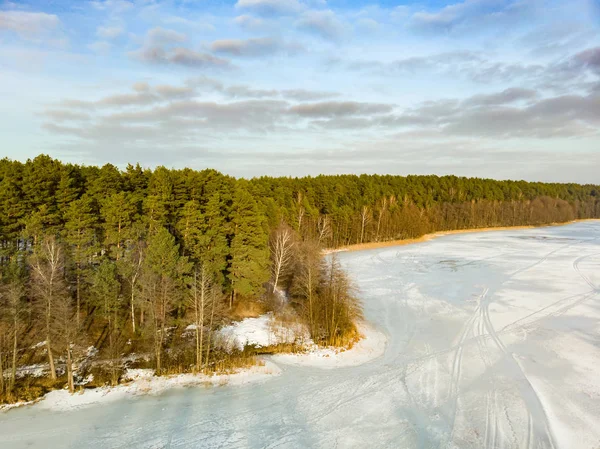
[{"x1": 326, "y1": 218, "x2": 600, "y2": 253}]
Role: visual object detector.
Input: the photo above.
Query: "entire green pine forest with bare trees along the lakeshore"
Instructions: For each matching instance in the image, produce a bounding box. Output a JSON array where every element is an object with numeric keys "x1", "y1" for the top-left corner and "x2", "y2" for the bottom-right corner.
[{"x1": 0, "y1": 155, "x2": 600, "y2": 399}]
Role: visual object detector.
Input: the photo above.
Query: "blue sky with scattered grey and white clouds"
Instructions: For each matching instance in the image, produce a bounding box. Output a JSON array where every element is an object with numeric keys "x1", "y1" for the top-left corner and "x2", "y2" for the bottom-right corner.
[{"x1": 0, "y1": 0, "x2": 600, "y2": 184}]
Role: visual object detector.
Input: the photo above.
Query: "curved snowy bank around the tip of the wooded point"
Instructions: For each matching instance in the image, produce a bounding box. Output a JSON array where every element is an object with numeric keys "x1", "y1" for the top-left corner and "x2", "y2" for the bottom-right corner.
[{"x1": 272, "y1": 323, "x2": 387, "y2": 369}]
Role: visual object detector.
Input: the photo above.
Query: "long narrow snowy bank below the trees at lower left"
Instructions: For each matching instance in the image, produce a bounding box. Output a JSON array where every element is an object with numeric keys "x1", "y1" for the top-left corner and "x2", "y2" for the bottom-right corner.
[{"x1": 19, "y1": 360, "x2": 281, "y2": 411}]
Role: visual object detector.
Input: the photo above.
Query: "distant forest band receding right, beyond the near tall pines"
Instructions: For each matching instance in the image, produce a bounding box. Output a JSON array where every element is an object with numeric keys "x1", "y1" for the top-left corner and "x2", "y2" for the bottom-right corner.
[{"x1": 250, "y1": 175, "x2": 600, "y2": 248}]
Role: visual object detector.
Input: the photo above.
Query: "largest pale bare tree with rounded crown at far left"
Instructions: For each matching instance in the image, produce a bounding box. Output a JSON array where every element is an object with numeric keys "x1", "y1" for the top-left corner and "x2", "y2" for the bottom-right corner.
[{"x1": 30, "y1": 236, "x2": 67, "y2": 380}]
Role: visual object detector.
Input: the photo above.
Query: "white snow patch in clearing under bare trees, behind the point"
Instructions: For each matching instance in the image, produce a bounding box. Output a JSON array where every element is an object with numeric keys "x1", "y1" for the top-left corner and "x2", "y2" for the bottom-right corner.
[{"x1": 218, "y1": 313, "x2": 310, "y2": 352}]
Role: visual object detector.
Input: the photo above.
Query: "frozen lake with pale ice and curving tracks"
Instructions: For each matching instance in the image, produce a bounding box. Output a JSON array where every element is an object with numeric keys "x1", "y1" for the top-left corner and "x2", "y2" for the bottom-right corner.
[{"x1": 0, "y1": 222, "x2": 600, "y2": 449}]
